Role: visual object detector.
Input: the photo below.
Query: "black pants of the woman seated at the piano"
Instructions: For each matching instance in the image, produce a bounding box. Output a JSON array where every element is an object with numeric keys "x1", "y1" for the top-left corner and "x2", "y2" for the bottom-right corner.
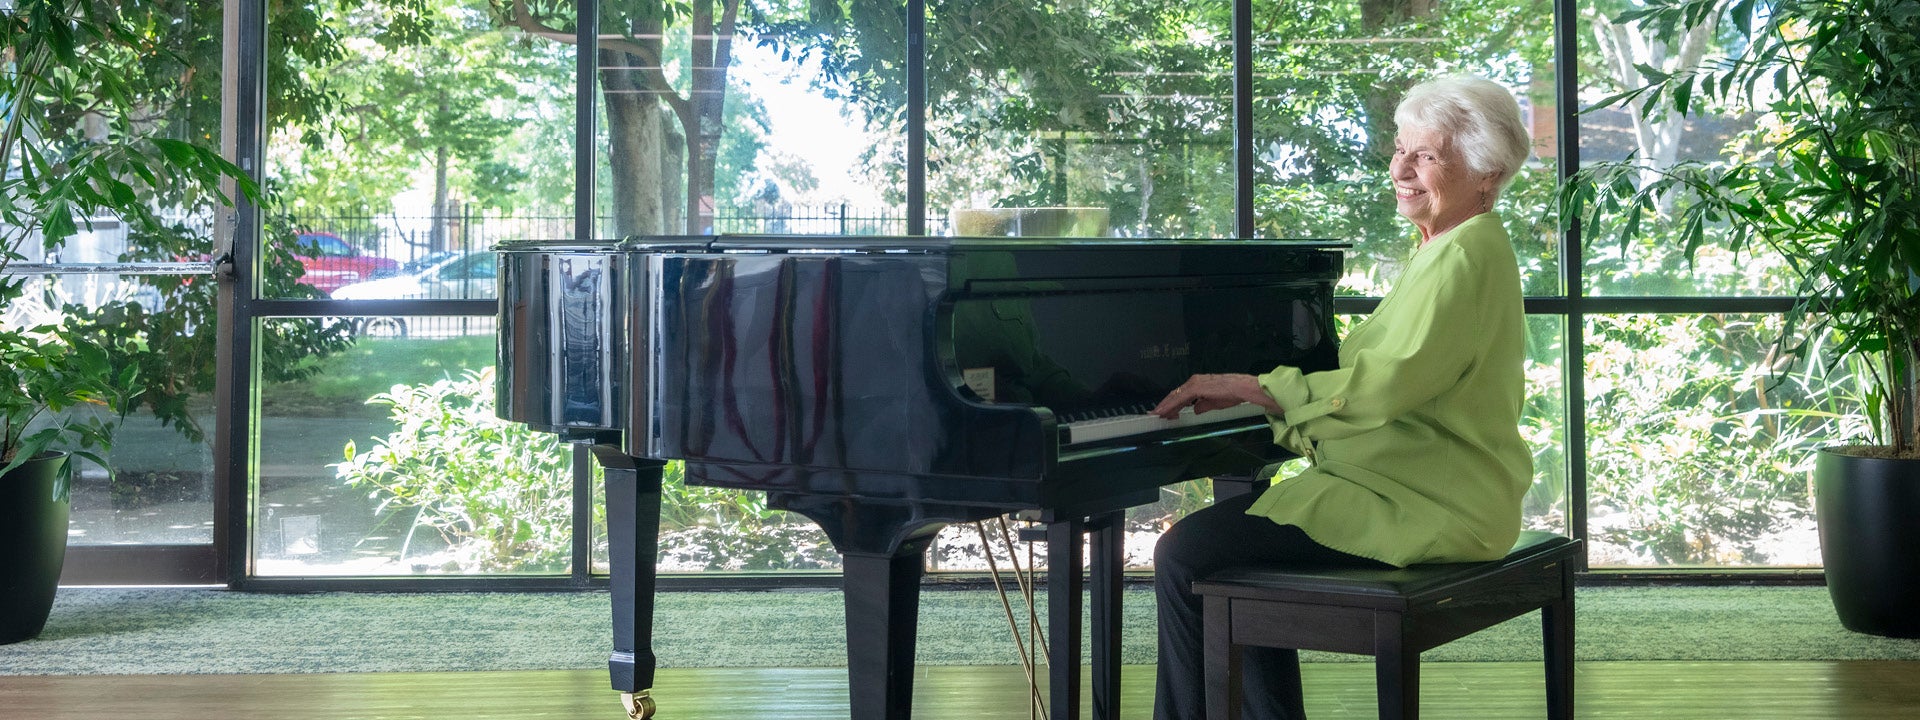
[{"x1": 1154, "y1": 493, "x2": 1386, "y2": 720}]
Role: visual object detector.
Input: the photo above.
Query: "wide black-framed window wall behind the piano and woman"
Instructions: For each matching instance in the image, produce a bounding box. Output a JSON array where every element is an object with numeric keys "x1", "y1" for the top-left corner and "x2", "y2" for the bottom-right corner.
[{"x1": 180, "y1": 0, "x2": 1859, "y2": 586}]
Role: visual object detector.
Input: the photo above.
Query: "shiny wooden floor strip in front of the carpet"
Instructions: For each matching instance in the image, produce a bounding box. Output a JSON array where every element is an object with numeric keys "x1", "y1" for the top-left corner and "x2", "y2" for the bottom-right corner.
[{"x1": 0, "y1": 660, "x2": 1920, "y2": 720}]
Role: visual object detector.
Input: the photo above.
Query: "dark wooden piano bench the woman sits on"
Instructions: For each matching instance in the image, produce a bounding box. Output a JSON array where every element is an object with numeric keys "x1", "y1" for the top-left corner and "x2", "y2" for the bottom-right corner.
[{"x1": 1194, "y1": 530, "x2": 1580, "y2": 720}]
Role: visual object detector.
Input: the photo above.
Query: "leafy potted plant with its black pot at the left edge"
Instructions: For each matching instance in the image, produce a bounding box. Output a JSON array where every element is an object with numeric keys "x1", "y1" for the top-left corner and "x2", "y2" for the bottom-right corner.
[{"x1": 0, "y1": 0, "x2": 253, "y2": 641}]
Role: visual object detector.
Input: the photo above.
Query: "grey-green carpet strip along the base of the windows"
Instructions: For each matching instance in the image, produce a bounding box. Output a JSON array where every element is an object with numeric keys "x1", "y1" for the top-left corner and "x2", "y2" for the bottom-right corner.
[{"x1": 0, "y1": 588, "x2": 1920, "y2": 674}]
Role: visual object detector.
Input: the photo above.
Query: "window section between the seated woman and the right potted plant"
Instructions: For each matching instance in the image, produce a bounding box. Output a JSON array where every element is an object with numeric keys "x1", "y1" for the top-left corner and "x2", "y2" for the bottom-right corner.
[{"x1": 1574, "y1": 2, "x2": 1862, "y2": 568}]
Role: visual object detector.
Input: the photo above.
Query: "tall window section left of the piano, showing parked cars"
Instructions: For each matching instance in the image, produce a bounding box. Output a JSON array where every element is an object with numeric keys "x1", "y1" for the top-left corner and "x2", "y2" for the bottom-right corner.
[{"x1": 243, "y1": 0, "x2": 591, "y2": 580}]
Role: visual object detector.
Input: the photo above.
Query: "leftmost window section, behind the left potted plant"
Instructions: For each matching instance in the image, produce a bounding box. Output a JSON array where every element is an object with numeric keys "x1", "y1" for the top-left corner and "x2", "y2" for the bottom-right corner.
[{"x1": 0, "y1": 0, "x2": 227, "y2": 556}]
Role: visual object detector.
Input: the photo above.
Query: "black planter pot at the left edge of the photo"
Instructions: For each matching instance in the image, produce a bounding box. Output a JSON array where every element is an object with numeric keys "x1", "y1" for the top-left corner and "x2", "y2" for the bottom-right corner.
[{"x1": 0, "y1": 453, "x2": 67, "y2": 645}]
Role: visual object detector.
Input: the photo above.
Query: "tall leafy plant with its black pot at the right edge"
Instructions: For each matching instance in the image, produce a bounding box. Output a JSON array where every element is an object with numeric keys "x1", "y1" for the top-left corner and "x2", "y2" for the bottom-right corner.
[{"x1": 1563, "y1": 0, "x2": 1920, "y2": 637}]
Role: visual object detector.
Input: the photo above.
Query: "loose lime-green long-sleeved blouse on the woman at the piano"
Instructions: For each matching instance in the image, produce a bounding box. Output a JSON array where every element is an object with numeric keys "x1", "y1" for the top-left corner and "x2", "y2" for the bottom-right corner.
[{"x1": 1248, "y1": 213, "x2": 1532, "y2": 566}]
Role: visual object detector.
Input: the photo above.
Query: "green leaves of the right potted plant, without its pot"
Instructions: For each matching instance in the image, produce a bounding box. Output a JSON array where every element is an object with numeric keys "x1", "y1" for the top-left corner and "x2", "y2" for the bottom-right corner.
[{"x1": 1563, "y1": 0, "x2": 1920, "y2": 457}]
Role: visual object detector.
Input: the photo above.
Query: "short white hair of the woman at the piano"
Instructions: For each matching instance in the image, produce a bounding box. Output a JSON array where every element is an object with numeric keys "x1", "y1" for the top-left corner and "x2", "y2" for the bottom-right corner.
[{"x1": 1394, "y1": 77, "x2": 1534, "y2": 188}]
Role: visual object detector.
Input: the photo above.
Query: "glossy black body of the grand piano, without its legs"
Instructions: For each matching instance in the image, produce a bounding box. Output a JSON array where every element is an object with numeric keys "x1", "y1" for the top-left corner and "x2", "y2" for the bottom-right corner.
[{"x1": 499, "y1": 236, "x2": 1342, "y2": 501}]
